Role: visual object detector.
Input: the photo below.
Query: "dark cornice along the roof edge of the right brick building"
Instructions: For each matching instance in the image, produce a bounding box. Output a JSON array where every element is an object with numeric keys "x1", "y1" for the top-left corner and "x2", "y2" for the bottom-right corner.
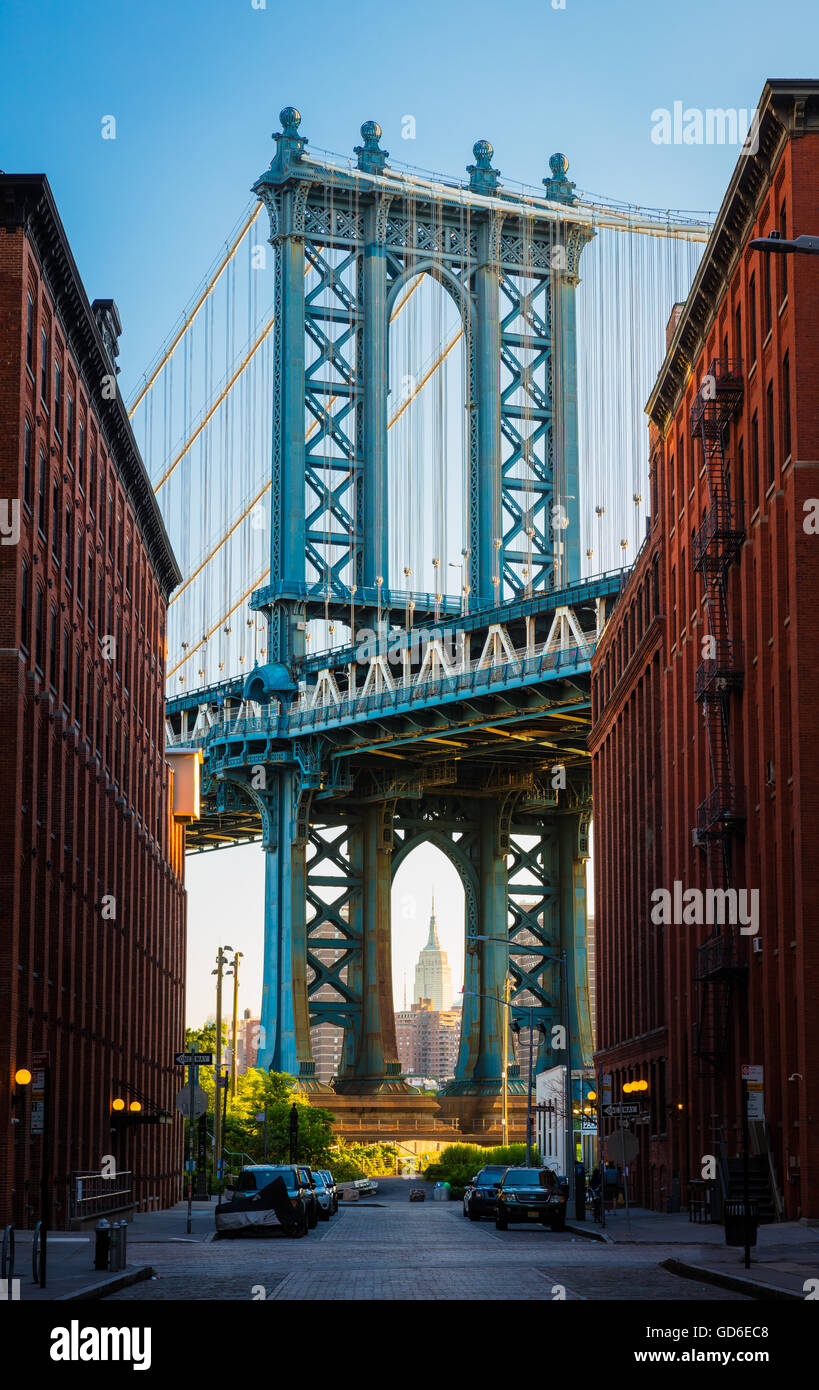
[{"x1": 645, "y1": 79, "x2": 819, "y2": 435}]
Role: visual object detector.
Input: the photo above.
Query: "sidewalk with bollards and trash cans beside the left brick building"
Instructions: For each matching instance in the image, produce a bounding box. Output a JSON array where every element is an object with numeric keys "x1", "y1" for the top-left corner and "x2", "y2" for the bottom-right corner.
[{"x1": 2, "y1": 1200, "x2": 216, "y2": 1302}]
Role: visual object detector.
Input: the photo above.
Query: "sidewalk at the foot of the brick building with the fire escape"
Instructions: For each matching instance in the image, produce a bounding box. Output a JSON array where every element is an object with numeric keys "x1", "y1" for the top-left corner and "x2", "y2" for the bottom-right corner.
[{"x1": 566, "y1": 1207, "x2": 819, "y2": 1301}]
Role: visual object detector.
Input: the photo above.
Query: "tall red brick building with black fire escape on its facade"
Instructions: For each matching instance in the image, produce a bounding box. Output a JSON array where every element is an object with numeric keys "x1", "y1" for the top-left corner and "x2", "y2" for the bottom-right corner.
[{"x1": 592, "y1": 82, "x2": 819, "y2": 1218}]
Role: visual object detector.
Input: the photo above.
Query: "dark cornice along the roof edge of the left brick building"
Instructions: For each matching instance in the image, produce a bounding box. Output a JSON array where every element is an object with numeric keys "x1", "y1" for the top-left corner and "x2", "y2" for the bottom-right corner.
[{"x1": 0, "y1": 174, "x2": 182, "y2": 599}]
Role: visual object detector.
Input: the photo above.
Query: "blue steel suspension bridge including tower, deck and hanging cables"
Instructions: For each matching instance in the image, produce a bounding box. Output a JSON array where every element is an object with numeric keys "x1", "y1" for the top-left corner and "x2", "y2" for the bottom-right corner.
[{"x1": 129, "y1": 107, "x2": 709, "y2": 1127}]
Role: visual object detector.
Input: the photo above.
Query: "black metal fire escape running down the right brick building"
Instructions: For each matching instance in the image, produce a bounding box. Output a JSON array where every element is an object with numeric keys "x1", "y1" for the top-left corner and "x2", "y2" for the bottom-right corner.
[{"x1": 691, "y1": 357, "x2": 748, "y2": 1074}]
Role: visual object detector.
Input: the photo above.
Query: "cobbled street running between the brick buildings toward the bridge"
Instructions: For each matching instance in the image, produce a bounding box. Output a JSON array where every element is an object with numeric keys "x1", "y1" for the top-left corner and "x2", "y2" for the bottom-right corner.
[{"x1": 107, "y1": 1180, "x2": 749, "y2": 1302}]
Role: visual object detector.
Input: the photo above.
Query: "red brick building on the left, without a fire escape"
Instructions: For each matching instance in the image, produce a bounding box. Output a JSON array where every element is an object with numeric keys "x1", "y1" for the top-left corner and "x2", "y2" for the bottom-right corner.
[{"x1": 0, "y1": 175, "x2": 185, "y2": 1227}]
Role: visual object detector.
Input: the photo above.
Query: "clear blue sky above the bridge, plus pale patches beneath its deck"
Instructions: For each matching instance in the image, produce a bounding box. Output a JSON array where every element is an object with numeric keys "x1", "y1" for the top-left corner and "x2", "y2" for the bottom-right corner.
[{"x1": 0, "y1": 0, "x2": 819, "y2": 1019}]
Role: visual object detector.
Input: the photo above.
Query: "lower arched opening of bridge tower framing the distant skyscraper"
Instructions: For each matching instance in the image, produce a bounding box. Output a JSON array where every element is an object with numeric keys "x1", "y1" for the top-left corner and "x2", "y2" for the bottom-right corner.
[{"x1": 392, "y1": 840, "x2": 466, "y2": 1086}]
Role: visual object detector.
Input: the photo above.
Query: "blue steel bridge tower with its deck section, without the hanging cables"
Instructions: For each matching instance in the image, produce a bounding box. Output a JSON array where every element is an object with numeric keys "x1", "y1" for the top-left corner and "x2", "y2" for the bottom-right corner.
[{"x1": 168, "y1": 108, "x2": 611, "y2": 1099}]
